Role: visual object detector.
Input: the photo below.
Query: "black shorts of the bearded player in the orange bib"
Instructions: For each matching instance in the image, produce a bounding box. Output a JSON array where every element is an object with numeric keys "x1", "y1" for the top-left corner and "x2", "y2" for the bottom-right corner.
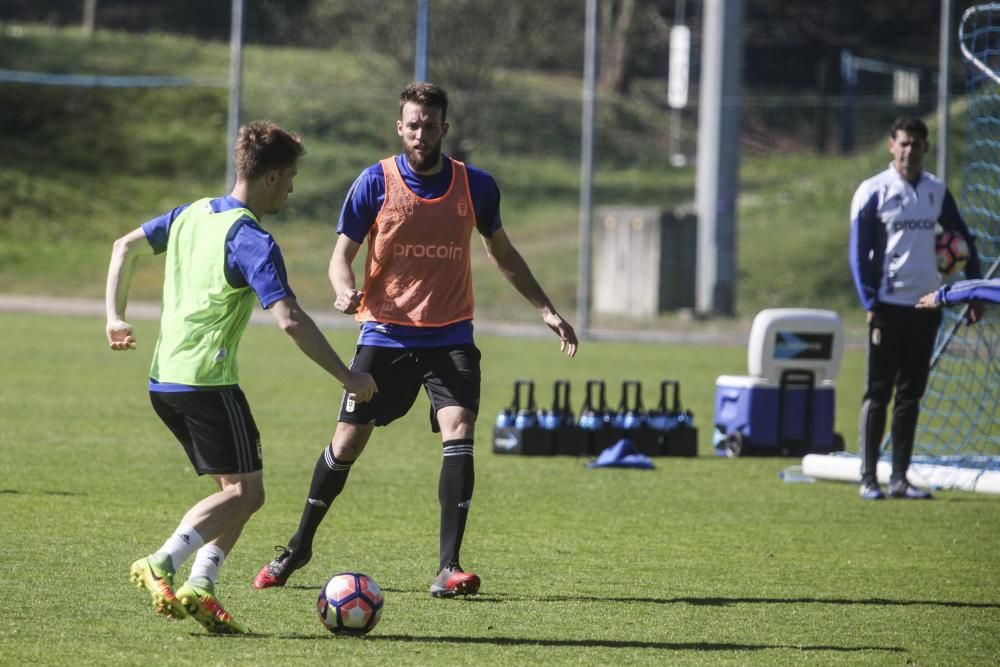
[{"x1": 340, "y1": 345, "x2": 480, "y2": 433}]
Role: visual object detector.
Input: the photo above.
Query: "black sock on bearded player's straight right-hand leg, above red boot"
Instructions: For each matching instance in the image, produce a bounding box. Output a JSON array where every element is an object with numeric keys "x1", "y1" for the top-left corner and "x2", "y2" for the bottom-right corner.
[{"x1": 438, "y1": 438, "x2": 476, "y2": 568}]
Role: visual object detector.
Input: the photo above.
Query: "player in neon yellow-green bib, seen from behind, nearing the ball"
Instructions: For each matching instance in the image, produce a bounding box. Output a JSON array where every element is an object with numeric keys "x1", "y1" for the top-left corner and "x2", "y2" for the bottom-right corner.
[{"x1": 106, "y1": 121, "x2": 377, "y2": 634}]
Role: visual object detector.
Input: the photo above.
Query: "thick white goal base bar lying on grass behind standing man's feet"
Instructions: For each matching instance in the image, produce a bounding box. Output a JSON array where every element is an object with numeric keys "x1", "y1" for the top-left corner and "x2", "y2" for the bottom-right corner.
[{"x1": 802, "y1": 454, "x2": 1000, "y2": 495}]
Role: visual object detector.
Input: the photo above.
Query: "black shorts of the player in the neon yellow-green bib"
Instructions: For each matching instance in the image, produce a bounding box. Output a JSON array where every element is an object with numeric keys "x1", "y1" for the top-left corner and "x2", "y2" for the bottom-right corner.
[{"x1": 149, "y1": 387, "x2": 263, "y2": 475}]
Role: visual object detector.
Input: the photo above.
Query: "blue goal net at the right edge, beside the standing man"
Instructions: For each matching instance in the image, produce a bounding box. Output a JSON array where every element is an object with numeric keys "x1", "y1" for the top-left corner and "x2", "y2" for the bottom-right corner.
[{"x1": 914, "y1": 3, "x2": 1000, "y2": 470}]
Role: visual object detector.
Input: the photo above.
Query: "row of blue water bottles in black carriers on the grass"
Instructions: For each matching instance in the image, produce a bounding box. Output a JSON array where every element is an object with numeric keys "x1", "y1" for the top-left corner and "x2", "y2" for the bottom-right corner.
[{"x1": 493, "y1": 379, "x2": 697, "y2": 456}]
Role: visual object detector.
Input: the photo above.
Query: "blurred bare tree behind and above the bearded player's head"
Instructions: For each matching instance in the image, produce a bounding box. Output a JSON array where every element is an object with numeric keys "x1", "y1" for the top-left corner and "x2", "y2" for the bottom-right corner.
[{"x1": 292, "y1": 0, "x2": 583, "y2": 159}]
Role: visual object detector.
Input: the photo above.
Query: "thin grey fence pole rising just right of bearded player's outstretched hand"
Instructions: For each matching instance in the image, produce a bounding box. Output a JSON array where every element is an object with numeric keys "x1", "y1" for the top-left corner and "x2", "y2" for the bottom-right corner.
[{"x1": 576, "y1": 0, "x2": 597, "y2": 338}]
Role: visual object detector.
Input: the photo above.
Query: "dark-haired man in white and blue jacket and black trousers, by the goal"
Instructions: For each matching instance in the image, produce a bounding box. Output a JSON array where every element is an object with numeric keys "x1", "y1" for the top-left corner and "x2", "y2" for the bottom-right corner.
[{"x1": 850, "y1": 117, "x2": 982, "y2": 500}]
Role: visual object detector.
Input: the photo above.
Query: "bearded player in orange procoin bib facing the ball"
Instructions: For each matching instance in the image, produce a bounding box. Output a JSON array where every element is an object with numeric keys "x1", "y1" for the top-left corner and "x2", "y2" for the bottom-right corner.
[{"x1": 254, "y1": 83, "x2": 577, "y2": 597}]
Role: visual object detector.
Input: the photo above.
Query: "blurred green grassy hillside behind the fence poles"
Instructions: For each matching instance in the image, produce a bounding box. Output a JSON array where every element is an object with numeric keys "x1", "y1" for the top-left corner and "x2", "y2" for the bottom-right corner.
[{"x1": 0, "y1": 26, "x2": 961, "y2": 327}]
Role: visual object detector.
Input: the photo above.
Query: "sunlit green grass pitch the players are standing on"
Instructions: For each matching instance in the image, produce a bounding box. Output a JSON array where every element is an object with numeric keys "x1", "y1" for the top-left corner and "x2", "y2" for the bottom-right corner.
[{"x1": 0, "y1": 314, "x2": 1000, "y2": 665}]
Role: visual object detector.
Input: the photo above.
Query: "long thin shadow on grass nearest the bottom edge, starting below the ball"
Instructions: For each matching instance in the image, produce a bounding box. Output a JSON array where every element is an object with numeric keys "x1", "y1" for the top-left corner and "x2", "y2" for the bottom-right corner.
[{"x1": 256, "y1": 634, "x2": 906, "y2": 653}]
